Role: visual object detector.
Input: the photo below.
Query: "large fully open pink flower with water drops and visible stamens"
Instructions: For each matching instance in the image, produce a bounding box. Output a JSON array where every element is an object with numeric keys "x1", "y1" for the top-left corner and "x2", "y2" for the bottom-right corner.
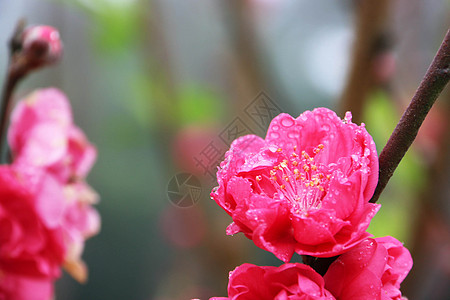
[{"x1": 211, "y1": 108, "x2": 379, "y2": 262}]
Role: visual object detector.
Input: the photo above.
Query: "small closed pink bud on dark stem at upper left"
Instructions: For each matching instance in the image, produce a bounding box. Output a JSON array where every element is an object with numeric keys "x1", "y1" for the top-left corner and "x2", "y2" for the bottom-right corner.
[{"x1": 22, "y1": 25, "x2": 63, "y2": 68}]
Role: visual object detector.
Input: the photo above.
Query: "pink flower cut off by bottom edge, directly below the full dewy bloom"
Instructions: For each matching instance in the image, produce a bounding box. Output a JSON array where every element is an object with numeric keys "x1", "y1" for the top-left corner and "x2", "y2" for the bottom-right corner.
[{"x1": 211, "y1": 263, "x2": 334, "y2": 300}]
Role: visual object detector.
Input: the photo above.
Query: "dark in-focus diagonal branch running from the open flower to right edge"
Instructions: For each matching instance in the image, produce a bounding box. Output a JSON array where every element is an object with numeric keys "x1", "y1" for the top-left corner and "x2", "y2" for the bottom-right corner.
[{"x1": 370, "y1": 30, "x2": 450, "y2": 203}]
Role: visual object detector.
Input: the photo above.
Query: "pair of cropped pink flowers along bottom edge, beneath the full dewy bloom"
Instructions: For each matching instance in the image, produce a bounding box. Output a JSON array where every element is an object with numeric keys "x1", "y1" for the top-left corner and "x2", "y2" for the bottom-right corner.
[{"x1": 211, "y1": 237, "x2": 412, "y2": 300}]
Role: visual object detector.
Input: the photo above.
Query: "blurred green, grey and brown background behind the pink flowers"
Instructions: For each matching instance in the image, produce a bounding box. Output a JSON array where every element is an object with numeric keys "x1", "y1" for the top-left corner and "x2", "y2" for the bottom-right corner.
[{"x1": 0, "y1": 0, "x2": 450, "y2": 300}]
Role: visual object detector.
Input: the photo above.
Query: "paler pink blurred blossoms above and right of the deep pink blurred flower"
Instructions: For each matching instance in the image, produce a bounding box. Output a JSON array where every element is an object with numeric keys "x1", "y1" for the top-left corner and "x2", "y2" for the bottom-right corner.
[{"x1": 8, "y1": 88, "x2": 100, "y2": 282}]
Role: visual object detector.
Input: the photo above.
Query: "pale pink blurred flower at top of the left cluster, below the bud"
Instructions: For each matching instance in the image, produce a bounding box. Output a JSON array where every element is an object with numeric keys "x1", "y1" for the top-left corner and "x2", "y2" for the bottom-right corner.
[{"x1": 8, "y1": 88, "x2": 97, "y2": 183}]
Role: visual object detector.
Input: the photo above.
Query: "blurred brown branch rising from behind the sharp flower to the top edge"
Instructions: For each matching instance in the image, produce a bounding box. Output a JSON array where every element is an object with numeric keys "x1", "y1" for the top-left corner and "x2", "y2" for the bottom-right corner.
[{"x1": 340, "y1": 0, "x2": 390, "y2": 123}]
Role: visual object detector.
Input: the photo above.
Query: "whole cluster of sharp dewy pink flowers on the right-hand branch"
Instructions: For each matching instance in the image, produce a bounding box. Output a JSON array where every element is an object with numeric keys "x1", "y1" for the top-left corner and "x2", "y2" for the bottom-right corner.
[{"x1": 211, "y1": 108, "x2": 412, "y2": 300}]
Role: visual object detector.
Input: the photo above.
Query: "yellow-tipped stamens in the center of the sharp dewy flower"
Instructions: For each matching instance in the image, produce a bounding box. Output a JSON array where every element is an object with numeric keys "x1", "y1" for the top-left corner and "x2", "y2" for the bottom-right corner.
[{"x1": 256, "y1": 144, "x2": 330, "y2": 212}]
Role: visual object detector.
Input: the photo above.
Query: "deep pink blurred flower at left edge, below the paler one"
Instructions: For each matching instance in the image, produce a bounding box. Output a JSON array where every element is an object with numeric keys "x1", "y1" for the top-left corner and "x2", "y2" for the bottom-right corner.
[{"x1": 0, "y1": 166, "x2": 66, "y2": 299}]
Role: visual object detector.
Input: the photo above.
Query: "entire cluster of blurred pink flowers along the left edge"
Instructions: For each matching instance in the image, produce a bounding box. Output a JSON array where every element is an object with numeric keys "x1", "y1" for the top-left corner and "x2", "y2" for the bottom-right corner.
[{"x1": 0, "y1": 88, "x2": 100, "y2": 300}]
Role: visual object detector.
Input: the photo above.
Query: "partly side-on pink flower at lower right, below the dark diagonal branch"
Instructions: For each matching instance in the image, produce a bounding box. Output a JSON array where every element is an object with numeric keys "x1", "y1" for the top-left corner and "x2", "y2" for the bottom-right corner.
[{"x1": 324, "y1": 236, "x2": 412, "y2": 300}]
